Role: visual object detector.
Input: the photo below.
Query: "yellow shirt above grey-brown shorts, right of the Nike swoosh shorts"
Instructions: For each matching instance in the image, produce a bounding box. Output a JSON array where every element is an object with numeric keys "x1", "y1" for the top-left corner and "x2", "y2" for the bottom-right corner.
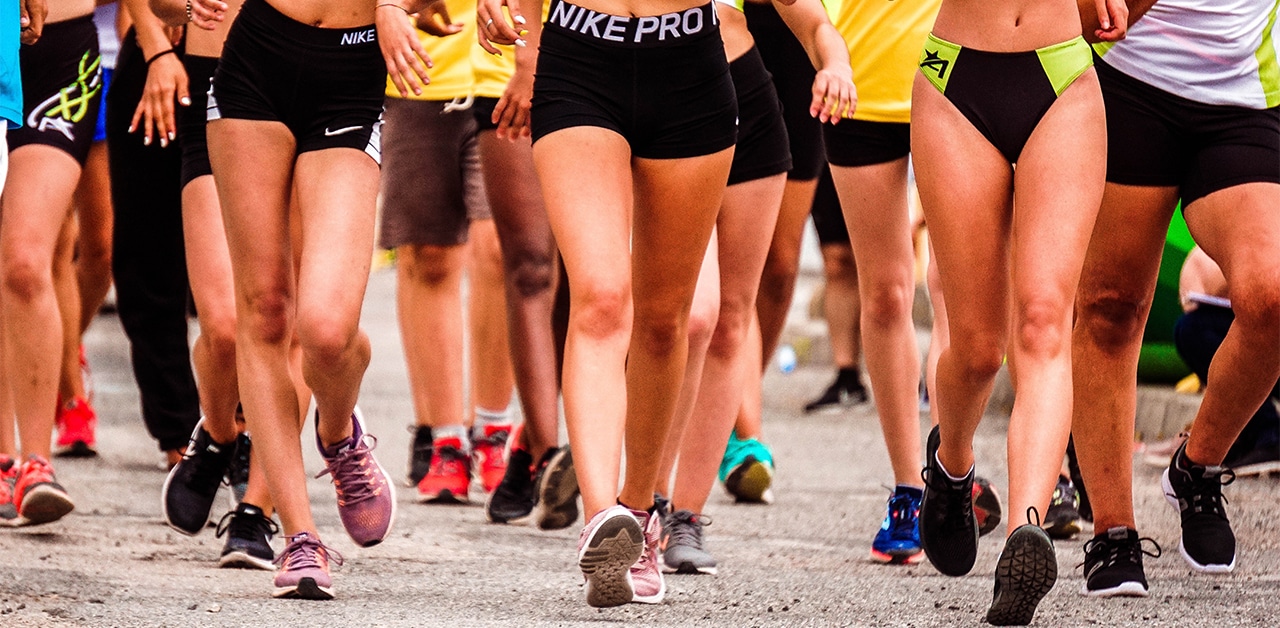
[{"x1": 387, "y1": 0, "x2": 481, "y2": 100}]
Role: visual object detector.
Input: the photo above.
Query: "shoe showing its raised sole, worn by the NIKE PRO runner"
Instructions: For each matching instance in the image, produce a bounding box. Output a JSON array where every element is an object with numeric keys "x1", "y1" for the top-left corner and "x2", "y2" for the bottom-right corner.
[{"x1": 577, "y1": 506, "x2": 644, "y2": 608}]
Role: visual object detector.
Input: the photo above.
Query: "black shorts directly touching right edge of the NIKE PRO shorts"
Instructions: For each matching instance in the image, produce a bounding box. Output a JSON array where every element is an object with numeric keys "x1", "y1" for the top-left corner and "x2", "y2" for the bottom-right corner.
[{"x1": 728, "y1": 47, "x2": 791, "y2": 185}]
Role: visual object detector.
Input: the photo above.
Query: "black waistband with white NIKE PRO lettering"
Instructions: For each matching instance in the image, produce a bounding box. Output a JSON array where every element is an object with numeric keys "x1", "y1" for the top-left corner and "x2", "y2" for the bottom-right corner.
[{"x1": 542, "y1": 0, "x2": 719, "y2": 47}]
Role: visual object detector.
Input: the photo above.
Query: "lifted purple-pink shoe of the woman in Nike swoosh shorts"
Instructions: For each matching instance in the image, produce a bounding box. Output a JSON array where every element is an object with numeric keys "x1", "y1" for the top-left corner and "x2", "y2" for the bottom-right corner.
[{"x1": 316, "y1": 408, "x2": 396, "y2": 547}]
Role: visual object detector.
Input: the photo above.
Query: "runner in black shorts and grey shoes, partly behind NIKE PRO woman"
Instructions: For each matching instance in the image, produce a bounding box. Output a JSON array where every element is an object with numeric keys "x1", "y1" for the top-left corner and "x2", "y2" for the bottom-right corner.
[{"x1": 655, "y1": 0, "x2": 855, "y2": 573}]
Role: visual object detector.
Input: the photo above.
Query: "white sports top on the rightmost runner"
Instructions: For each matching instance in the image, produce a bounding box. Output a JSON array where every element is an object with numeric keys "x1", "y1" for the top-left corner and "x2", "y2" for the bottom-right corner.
[{"x1": 1094, "y1": 0, "x2": 1280, "y2": 109}]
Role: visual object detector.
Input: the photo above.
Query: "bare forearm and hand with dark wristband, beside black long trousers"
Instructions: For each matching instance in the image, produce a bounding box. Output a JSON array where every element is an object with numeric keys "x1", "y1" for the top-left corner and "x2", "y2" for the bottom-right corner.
[{"x1": 123, "y1": 0, "x2": 191, "y2": 147}]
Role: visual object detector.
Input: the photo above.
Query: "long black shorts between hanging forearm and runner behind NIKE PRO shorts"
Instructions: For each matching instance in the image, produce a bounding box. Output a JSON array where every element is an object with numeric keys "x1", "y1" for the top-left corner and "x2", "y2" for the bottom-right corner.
[{"x1": 740, "y1": 3, "x2": 827, "y2": 180}]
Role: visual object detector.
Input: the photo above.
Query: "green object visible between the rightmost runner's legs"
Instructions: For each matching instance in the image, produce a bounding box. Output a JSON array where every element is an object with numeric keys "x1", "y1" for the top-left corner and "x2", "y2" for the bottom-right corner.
[{"x1": 1138, "y1": 203, "x2": 1196, "y2": 384}]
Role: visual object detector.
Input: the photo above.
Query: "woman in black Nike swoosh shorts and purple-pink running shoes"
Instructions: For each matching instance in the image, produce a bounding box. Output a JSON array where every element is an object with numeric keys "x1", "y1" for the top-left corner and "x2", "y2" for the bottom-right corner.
[{"x1": 186, "y1": 0, "x2": 426, "y2": 599}]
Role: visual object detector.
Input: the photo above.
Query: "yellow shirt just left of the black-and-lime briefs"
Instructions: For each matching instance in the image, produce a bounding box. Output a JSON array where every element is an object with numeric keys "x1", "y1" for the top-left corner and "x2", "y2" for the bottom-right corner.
[{"x1": 835, "y1": 0, "x2": 942, "y2": 123}]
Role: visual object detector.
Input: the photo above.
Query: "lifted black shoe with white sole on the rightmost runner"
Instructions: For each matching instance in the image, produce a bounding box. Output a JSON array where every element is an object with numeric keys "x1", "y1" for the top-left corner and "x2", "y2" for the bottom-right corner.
[{"x1": 1161, "y1": 443, "x2": 1235, "y2": 573}]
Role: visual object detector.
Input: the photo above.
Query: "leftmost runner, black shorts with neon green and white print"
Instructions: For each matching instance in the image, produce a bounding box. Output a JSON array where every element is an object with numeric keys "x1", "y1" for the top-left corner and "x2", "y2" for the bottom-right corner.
[{"x1": 0, "y1": 0, "x2": 102, "y2": 524}]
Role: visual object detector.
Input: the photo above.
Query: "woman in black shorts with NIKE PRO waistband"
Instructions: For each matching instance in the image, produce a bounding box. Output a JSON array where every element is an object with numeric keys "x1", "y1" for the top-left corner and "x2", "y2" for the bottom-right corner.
[{"x1": 477, "y1": 0, "x2": 737, "y2": 606}]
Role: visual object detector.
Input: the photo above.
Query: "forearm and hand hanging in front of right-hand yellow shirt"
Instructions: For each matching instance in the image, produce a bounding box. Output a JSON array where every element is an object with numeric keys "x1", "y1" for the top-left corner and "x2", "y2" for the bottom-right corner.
[{"x1": 777, "y1": 0, "x2": 858, "y2": 123}]
